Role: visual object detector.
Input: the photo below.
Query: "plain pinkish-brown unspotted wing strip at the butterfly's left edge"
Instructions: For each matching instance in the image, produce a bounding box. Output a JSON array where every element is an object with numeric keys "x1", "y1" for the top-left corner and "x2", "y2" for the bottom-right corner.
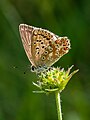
[{"x1": 19, "y1": 24, "x2": 35, "y2": 66}]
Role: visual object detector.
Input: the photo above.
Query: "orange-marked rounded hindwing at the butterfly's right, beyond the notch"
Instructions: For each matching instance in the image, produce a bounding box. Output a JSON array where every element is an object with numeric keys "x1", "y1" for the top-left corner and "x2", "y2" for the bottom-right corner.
[{"x1": 44, "y1": 37, "x2": 70, "y2": 66}]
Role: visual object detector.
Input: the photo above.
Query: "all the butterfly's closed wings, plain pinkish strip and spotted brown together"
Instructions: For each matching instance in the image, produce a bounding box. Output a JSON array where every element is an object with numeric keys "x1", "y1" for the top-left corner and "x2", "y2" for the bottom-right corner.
[{"x1": 19, "y1": 24, "x2": 70, "y2": 70}]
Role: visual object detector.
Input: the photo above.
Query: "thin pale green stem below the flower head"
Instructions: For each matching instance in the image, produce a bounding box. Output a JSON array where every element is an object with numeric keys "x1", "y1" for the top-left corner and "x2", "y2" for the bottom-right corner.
[{"x1": 55, "y1": 91, "x2": 62, "y2": 120}]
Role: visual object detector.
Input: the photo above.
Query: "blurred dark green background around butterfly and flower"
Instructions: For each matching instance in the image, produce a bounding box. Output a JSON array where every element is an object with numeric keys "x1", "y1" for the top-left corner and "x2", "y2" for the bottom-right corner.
[{"x1": 0, "y1": 0, "x2": 90, "y2": 120}]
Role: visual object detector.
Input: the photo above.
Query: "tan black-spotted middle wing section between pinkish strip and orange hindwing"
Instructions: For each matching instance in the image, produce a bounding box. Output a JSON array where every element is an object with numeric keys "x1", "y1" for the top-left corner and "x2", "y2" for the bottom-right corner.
[{"x1": 31, "y1": 28, "x2": 57, "y2": 66}]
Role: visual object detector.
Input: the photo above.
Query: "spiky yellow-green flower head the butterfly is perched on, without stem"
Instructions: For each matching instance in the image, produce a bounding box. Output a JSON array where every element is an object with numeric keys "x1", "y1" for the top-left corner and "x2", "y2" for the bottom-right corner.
[{"x1": 33, "y1": 65, "x2": 78, "y2": 93}]
